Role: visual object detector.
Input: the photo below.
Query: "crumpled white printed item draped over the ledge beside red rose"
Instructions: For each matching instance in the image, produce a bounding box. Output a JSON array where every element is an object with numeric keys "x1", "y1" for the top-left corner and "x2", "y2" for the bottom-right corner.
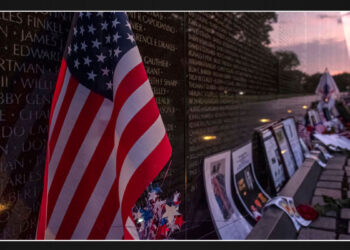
[{"x1": 264, "y1": 196, "x2": 311, "y2": 231}]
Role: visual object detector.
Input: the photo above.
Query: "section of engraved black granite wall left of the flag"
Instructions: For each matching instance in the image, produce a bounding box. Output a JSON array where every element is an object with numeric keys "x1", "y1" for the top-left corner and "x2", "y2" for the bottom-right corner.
[{"x1": 0, "y1": 12, "x2": 72, "y2": 239}]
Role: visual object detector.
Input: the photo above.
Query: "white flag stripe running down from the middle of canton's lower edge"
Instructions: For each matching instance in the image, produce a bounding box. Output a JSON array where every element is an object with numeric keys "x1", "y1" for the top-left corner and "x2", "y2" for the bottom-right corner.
[{"x1": 48, "y1": 84, "x2": 91, "y2": 190}]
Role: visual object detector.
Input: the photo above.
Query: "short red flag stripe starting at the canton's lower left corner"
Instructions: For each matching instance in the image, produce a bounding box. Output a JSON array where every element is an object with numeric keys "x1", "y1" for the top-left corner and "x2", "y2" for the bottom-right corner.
[{"x1": 49, "y1": 77, "x2": 79, "y2": 159}]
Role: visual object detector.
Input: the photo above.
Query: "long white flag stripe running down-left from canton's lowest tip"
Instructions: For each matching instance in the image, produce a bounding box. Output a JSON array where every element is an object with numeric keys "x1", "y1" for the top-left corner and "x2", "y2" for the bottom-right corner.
[{"x1": 48, "y1": 99, "x2": 113, "y2": 237}]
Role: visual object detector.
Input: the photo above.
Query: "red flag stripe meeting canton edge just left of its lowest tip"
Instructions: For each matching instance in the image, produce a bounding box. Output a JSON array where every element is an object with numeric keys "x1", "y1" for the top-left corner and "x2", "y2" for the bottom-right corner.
[{"x1": 48, "y1": 92, "x2": 104, "y2": 221}]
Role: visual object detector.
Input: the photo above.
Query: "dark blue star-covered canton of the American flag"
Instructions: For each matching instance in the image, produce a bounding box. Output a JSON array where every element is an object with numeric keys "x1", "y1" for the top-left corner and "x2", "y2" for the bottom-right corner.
[{"x1": 66, "y1": 12, "x2": 136, "y2": 100}]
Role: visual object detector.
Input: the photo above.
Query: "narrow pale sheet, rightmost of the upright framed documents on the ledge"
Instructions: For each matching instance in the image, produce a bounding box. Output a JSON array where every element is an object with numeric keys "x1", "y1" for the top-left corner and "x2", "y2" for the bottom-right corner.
[{"x1": 282, "y1": 117, "x2": 304, "y2": 168}]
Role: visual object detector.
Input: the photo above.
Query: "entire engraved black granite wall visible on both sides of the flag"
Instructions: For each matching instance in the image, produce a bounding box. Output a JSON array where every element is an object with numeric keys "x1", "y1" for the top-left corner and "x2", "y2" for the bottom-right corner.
[{"x1": 0, "y1": 12, "x2": 322, "y2": 239}]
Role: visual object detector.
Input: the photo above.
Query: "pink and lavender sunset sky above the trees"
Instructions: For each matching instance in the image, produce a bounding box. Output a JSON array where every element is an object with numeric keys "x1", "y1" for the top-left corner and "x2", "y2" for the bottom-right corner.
[{"x1": 270, "y1": 11, "x2": 350, "y2": 75}]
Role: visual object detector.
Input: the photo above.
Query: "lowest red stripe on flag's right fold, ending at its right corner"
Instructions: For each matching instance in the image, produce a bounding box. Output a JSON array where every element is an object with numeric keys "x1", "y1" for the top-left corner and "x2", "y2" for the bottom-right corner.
[{"x1": 121, "y1": 134, "x2": 172, "y2": 239}]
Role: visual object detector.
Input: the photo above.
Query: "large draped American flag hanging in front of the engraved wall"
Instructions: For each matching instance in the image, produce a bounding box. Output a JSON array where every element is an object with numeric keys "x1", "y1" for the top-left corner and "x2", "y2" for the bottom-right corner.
[{"x1": 37, "y1": 12, "x2": 172, "y2": 239}]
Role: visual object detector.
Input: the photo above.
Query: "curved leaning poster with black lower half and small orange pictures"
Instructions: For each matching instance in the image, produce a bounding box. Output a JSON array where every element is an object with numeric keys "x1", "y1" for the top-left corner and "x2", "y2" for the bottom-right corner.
[{"x1": 232, "y1": 143, "x2": 270, "y2": 220}]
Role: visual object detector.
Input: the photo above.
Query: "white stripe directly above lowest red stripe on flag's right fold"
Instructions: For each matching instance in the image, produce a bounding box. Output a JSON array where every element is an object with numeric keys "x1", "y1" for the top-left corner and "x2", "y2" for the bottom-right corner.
[{"x1": 119, "y1": 115, "x2": 165, "y2": 204}]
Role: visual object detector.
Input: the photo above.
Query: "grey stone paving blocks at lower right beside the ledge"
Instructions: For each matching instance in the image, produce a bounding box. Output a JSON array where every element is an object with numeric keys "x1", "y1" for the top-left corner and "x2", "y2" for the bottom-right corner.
[{"x1": 298, "y1": 155, "x2": 350, "y2": 240}]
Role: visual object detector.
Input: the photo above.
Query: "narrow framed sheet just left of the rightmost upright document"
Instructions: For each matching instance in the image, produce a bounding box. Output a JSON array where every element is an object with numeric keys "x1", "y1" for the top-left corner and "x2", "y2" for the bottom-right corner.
[{"x1": 272, "y1": 123, "x2": 297, "y2": 178}]
